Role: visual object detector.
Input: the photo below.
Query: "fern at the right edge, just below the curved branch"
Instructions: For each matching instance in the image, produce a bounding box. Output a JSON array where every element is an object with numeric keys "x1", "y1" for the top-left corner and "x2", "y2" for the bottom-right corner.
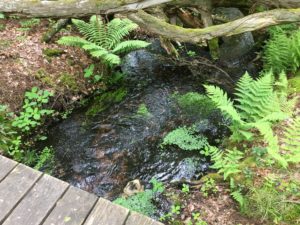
[{"x1": 264, "y1": 27, "x2": 300, "y2": 74}]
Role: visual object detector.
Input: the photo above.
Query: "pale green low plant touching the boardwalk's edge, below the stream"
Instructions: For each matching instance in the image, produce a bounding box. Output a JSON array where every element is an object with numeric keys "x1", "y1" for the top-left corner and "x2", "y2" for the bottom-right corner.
[{"x1": 114, "y1": 179, "x2": 164, "y2": 216}]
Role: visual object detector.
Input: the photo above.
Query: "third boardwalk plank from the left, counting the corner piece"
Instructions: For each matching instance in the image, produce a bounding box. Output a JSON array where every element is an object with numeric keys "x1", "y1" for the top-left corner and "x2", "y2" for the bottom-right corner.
[{"x1": 3, "y1": 175, "x2": 68, "y2": 225}]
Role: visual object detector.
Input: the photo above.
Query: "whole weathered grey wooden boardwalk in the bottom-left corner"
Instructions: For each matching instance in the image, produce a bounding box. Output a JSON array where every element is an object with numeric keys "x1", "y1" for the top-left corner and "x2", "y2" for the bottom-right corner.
[{"x1": 0, "y1": 156, "x2": 162, "y2": 225}]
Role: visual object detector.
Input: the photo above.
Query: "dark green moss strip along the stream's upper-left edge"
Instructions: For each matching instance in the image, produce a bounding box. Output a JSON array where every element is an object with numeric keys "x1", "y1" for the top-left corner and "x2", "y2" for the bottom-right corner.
[{"x1": 86, "y1": 88, "x2": 127, "y2": 116}]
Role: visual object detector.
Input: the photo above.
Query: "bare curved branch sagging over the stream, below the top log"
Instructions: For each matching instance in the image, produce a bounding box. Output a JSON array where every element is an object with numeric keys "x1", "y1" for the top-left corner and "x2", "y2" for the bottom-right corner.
[{"x1": 128, "y1": 8, "x2": 300, "y2": 43}]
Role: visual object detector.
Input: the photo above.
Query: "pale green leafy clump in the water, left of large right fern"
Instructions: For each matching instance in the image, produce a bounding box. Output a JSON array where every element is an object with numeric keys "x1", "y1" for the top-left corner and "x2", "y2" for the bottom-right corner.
[{"x1": 161, "y1": 127, "x2": 208, "y2": 151}]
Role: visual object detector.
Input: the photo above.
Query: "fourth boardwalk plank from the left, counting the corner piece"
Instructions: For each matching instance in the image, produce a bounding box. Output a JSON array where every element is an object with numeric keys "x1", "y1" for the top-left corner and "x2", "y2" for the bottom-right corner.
[{"x1": 43, "y1": 187, "x2": 98, "y2": 225}]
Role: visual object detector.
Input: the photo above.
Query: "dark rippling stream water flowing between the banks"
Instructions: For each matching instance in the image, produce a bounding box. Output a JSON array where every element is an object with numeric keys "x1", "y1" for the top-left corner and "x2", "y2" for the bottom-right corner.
[{"x1": 47, "y1": 50, "x2": 232, "y2": 199}]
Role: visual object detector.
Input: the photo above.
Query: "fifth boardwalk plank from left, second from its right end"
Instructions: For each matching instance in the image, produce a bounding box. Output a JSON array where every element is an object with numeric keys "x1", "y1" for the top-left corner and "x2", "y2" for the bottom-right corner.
[{"x1": 84, "y1": 198, "x2": 129, "y2": 225}]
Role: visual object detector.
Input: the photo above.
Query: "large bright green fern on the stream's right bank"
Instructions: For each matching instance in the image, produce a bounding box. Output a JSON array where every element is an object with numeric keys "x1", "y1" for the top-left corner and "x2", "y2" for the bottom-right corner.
[{"x1": 205, "y1": 71, "x2": 288, "y2": 167}]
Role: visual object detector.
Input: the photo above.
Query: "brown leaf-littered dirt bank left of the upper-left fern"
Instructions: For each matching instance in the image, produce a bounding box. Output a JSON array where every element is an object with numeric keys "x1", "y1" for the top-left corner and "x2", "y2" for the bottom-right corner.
[{"x1": 0, "y1": 19, "x2": 92, "y2": 111}]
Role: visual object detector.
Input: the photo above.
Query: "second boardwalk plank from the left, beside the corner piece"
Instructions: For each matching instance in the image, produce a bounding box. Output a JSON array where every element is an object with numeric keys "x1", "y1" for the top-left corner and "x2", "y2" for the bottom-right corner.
[{"x1": 0, "y1": 164, "x2": 42, "y2": 224}]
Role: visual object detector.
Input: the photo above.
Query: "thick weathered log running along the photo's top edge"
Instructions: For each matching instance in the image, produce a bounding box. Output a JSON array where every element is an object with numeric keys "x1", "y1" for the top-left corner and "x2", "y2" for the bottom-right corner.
[{"x1": 0, "y1": 0, "x2": 300, "y2": 17}]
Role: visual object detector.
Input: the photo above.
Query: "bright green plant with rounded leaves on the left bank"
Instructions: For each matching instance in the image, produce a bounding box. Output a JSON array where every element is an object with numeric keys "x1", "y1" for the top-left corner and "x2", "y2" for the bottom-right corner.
[{"x1": 12, "y1": 87, "x2": 54, "y2": 132}]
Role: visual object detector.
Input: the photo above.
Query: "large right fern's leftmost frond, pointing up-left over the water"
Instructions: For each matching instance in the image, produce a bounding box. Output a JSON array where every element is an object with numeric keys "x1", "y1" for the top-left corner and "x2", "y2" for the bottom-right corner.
[{"x1": 204, "y1": 85, "x2": 243, "y2": 123}]
